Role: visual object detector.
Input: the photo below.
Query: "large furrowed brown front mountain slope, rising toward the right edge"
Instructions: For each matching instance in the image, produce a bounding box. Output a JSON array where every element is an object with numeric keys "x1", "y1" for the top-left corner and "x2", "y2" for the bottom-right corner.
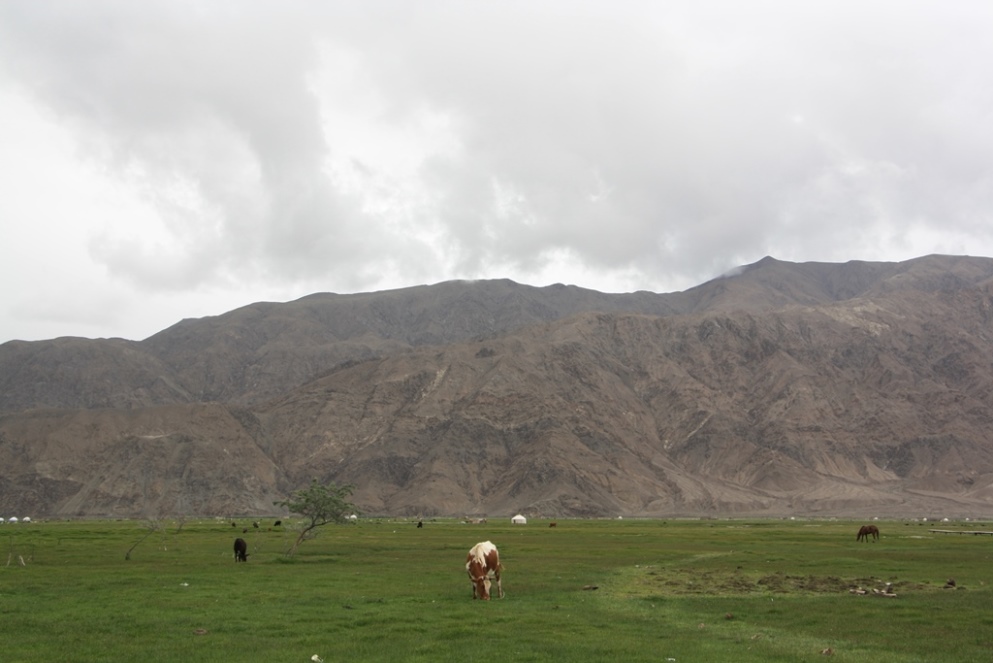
[{"x1": 261, "y1": 272, "x2": 993, "y2": 514}]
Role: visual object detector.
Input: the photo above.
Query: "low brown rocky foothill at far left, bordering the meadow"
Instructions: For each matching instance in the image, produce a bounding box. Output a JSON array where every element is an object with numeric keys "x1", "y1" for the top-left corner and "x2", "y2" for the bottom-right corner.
[{"x1": 0, "y1": 404, "x2": 286, "y2": 517}]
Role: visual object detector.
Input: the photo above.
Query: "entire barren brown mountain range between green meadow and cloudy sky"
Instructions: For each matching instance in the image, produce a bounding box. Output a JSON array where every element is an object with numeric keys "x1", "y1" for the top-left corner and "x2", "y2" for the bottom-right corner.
[{"x1": 0, "y1": 256, "x2": 993, "y2": 517}]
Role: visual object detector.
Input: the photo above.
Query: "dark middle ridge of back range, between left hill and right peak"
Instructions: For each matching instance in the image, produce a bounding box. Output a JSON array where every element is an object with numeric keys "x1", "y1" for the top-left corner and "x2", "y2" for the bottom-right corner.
[{"x1": 142, "y1": 280, "x2": 671, "y2": 404}]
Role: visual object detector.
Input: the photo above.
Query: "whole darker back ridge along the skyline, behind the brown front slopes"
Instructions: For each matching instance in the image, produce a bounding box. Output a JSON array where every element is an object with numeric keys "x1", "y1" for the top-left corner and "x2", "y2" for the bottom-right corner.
[{"x1": 0, "y1": 256, "x2": 993, "y2": 412}]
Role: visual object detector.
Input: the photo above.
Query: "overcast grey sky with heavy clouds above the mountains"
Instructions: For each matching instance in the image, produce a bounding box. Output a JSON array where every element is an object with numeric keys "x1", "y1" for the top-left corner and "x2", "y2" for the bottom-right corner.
[{"x1": 0, "y1": 0, "x2": 993, "y2": 342}]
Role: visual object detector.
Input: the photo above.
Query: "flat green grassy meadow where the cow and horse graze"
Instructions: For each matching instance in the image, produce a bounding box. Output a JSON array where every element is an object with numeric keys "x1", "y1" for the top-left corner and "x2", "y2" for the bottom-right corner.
[{"x1": 0, "y1": 519, "x2": 993, "y2": 663}]
